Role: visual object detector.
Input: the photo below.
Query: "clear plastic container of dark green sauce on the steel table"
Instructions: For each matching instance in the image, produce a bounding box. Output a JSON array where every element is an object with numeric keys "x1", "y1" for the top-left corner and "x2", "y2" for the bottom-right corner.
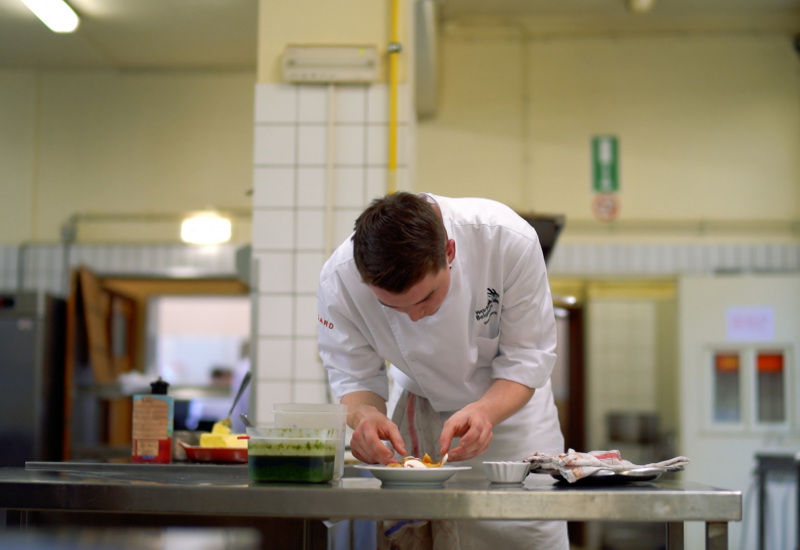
[{"x1": 247, "y1": 428, "x2": 341, "y2": 483}]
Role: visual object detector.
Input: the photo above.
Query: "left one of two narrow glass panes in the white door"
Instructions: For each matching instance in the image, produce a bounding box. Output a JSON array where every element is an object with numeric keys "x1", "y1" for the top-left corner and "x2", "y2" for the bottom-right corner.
[{"x1": 711, "y1": 349, "x2": 743, "y2": 427}]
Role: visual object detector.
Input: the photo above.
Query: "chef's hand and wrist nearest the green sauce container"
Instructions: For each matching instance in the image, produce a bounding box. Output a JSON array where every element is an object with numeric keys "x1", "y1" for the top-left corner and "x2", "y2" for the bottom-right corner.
[{"x1": 342, "y1": 391, "x2": 406, "y2": 464}]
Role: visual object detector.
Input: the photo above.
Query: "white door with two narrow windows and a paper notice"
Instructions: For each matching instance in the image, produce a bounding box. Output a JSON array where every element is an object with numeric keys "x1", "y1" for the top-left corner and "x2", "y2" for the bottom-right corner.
[{"x1": 678, "y1": 275, "x2": 800, "y2": 549}]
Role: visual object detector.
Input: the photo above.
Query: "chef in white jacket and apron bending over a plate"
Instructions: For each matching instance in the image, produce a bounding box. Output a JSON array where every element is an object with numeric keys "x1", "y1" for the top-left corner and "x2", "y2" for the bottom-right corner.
[{"x1": 317, "y1": 192, "x2": 569, "y2": 550}]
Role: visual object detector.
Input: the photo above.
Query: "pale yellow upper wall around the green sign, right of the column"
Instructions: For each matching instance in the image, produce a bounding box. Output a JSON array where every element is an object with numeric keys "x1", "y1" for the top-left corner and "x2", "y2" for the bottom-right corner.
[{"x1": 415, "y1": 26, "x2": 800, "y2": 234}]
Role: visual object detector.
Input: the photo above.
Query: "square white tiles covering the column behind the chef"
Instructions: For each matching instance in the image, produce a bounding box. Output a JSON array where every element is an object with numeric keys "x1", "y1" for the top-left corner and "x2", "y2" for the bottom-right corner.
[{"x1": 253, "y1": 83, "x2": 413, "y2": 422}]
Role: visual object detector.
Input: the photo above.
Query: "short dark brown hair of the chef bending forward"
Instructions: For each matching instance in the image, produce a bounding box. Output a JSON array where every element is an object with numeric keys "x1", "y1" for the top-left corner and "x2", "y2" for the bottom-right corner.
[{"x1": 353, "y1": 191, "x2": 447, "y2": 293}]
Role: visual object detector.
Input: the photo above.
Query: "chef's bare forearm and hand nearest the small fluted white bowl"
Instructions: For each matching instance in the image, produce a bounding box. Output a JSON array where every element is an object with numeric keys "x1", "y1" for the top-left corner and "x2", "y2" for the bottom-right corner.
[{"x1": 439, "y1": 379, "x2": 534, "y2": 460}]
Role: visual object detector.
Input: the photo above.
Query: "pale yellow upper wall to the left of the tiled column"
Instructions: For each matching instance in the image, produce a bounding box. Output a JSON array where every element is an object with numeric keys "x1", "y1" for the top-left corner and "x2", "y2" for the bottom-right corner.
[{"x1": 0, "y1": 70, "x2": 255, "y2": 243}]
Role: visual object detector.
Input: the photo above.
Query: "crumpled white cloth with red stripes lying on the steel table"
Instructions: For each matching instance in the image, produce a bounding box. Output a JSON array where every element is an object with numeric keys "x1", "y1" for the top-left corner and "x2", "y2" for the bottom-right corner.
[{"x1": 524, "y1": 449, "x2": 691, "y2": 483}]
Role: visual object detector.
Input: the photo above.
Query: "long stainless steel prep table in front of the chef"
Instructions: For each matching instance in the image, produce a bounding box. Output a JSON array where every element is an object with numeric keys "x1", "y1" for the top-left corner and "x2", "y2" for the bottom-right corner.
[{"x1": 0, "y1": 463, "x2": 742, "y2": 550}]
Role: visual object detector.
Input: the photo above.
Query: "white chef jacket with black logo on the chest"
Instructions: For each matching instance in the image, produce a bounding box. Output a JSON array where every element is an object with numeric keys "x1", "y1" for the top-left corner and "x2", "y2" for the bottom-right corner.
[{"x1": 317, "y1": 195, "x2": 556, "y2": 411}]
